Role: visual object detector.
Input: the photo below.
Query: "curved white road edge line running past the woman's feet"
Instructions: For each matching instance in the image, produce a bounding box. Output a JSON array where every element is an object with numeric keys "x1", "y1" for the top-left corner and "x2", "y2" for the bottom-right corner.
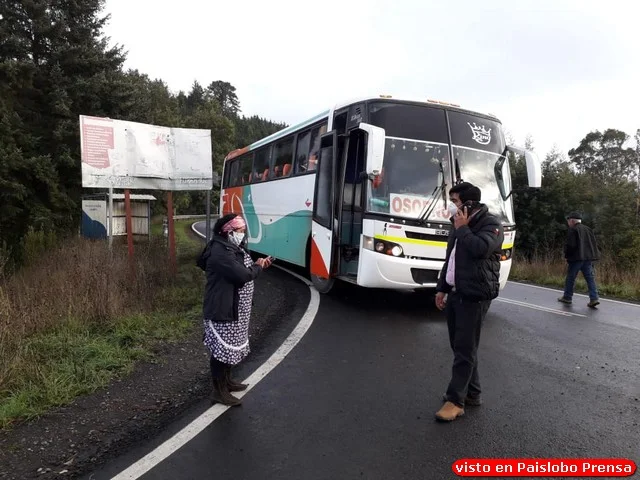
[{"x1": 113, "y1": 229, "x2": 320, "y2": 480}]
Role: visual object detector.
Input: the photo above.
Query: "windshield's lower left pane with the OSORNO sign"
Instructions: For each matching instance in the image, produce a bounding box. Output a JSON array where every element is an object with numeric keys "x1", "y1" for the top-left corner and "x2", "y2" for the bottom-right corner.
[{"x1": 369, "y1": 137, "x2": 449, "y2": 222}]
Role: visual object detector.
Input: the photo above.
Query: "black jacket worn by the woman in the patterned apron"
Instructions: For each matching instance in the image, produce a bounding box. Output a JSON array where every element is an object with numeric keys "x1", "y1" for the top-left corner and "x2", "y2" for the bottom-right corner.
[{"x1": 202, "y1": 236, "x2": 262, "y2": 322}]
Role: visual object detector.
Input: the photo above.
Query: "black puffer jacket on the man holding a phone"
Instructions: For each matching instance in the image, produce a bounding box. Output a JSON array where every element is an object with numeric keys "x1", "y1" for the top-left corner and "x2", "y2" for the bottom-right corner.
[{"x1": 436, "y1": 204, "x2": 504, "y2": 301}]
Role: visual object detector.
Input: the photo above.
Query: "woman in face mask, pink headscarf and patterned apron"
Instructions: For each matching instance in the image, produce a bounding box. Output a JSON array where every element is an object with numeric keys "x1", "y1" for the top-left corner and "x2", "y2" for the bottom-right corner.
[{"x1": 203, "y1": 213, "x2": 272, "y2": 405}]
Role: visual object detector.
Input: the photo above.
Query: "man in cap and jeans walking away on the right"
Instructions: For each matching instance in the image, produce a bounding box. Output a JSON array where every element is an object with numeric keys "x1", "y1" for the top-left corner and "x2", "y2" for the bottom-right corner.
[{"x1": 558, "y1": 212, "x2": 600, "y2": 308}]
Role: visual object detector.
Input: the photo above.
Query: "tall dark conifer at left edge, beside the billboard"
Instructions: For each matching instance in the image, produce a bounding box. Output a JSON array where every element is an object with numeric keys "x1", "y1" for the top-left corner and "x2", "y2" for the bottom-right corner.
[{"x1": 0, "y1": 0, "x2": 129, "y2": 264}]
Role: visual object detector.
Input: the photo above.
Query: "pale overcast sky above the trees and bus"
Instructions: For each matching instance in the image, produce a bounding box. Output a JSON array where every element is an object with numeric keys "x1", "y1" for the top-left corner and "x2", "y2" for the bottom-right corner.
[{"x1": 103, "y1": 0, "x2": 640, "y2": 157}]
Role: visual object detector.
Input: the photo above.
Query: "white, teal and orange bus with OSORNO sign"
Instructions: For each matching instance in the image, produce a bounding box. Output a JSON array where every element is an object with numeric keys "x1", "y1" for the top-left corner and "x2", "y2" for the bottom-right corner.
[{"x1": 220, "y1": 96, "x2": 541, "y2": 293}]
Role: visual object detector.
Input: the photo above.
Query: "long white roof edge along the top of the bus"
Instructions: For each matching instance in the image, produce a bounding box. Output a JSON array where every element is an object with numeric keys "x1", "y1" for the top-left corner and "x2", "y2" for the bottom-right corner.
[{"x1": 224, "y1": 95, "x2": 500, "y2": 162}]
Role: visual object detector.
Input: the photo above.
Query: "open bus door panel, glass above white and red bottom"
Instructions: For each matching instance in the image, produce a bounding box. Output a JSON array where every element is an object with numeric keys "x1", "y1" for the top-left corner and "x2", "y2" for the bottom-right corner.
[{"x1": 309, "y1": 130, "x2": 338, "y2": 293}]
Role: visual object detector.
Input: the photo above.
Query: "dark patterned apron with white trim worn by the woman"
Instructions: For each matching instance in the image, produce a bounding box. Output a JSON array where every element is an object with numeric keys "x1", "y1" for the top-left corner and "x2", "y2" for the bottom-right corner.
[{"x1": 203, "y1": 253, "x2": 254, "y2": 365}]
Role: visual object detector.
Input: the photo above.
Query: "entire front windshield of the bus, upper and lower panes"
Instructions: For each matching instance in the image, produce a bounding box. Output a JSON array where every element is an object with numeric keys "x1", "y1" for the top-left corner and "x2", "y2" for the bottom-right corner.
[{"x1": 368, "y1": 101, "x2": 514, "y2": 223}]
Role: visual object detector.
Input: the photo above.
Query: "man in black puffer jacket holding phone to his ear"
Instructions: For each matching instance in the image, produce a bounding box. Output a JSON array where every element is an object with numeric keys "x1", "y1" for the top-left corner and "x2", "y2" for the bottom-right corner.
[{"x1": 435, "y1": 182, "x2": 504, "y2": 422}]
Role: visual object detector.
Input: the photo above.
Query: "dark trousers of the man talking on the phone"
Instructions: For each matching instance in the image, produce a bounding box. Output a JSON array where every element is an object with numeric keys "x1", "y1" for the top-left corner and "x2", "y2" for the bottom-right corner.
[{"x1": 445, "y1": 293, "x2": 491, "y2": 407}]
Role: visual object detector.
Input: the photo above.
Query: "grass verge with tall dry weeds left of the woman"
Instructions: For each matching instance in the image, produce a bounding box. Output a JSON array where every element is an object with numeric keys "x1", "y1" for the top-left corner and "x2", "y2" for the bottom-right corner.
[{"x1": 0, "y1": 220, "x2": 203, "y2": 429}]
